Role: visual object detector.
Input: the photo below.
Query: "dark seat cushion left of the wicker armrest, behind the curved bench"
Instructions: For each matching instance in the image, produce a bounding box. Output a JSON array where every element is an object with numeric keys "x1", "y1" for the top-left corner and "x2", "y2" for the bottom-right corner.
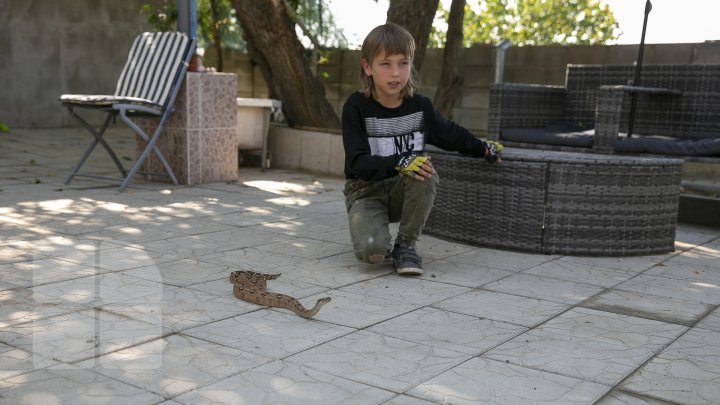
[{"x1": 500, "y1": 124, "x2": 595, "y2": 148}]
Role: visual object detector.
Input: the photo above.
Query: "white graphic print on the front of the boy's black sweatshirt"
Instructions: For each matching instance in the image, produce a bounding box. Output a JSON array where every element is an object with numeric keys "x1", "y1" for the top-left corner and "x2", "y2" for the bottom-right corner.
[{"x1": 365, "y1": 112, "x2": 425, "y2": 156}]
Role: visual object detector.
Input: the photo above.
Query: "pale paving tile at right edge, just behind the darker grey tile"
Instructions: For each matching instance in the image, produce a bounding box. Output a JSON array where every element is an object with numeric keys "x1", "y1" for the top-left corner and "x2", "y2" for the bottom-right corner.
[{"x1": 615, "y1": 274, "x2": 720, "y2": 305}]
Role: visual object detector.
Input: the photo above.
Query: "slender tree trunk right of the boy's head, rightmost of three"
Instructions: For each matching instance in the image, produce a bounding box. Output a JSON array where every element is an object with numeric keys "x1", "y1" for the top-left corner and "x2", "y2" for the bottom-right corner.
[{"x1": 434, "y1": 0, "x2": 465, "y2": 118}]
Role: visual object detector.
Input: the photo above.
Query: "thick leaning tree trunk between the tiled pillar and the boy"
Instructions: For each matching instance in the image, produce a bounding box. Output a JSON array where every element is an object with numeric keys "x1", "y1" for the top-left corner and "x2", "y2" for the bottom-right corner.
[{"x1": 232, "y1": 0, "x2": 340, "y2": 129}]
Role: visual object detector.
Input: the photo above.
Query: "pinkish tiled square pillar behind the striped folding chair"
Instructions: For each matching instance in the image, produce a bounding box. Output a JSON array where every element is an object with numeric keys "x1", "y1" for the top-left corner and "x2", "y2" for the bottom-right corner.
[{"x1": 137, "y1": 72, "x2": 238, "y2": 185}]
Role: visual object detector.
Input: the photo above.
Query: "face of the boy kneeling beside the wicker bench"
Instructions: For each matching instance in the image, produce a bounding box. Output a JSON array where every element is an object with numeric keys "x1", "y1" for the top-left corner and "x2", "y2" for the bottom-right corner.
[{"x1": 362, "y1": 53, "x2": 412, "y2": 107}]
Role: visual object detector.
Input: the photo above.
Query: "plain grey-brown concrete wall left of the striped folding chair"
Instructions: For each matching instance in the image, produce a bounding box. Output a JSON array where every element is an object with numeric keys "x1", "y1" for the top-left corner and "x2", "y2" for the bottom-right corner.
[{"x1": 0, "y1": 0, "x2": 150, "y2": 127}]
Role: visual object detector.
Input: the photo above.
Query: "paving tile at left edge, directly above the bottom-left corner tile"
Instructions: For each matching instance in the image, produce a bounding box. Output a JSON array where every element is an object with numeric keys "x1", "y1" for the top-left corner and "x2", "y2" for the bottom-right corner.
[{"x1": 0, "y1": 309, "x2": 163, "y2": 363}]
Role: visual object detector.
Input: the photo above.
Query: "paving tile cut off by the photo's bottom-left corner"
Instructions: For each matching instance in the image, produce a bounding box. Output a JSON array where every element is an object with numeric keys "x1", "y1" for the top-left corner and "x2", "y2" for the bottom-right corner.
[{"x1": 0, "y1": 365, "x2": 164, "y2": 405}]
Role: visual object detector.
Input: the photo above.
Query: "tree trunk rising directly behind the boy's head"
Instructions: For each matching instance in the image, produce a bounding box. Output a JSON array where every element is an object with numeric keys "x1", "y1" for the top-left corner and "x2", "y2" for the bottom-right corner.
[{"x1": 387, "y1": 0, "x2": 440, "y2": 73}]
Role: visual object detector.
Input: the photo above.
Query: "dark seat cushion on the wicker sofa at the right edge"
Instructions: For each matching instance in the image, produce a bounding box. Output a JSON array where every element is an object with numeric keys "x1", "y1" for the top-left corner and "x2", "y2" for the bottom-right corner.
[{"x1": 615, "y1": 134, "x2": 720, "y2": 156}]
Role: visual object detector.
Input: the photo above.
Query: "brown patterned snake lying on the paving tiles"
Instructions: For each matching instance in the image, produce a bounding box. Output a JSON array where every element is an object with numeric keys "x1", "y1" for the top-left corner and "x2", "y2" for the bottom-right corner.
[{"x1": 230, "y1": 271, "x2": 330, "y2": 318}]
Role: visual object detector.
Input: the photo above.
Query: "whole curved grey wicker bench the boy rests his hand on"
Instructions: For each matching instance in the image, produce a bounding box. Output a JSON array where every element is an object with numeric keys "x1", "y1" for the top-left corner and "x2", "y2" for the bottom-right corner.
[{"x1": 425, "y1": 148, "x2": 683, "y2": 256}]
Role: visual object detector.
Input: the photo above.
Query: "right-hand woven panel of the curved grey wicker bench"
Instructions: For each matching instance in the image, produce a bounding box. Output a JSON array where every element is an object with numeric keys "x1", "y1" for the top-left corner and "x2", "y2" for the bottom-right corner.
[{"x1": 543, "y1": 159, "x2": 682, "y2": 255}]
